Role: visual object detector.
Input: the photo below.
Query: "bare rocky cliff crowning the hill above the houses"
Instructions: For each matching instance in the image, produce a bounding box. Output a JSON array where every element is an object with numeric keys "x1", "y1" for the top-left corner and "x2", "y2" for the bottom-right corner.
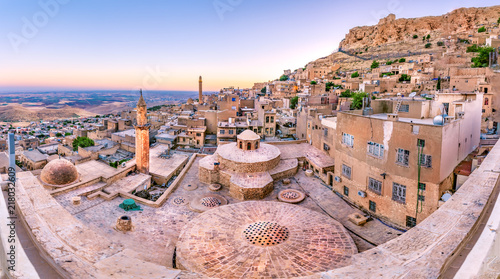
[{"x1": 339, "y1": 6, "x2": 500, "y2": 49}]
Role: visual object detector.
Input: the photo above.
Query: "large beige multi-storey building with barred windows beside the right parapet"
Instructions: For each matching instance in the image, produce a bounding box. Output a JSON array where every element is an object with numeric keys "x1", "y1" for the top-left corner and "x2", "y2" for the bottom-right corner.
[{"x1": 334, "y1": 94, "x2": 483, "y2": 227}]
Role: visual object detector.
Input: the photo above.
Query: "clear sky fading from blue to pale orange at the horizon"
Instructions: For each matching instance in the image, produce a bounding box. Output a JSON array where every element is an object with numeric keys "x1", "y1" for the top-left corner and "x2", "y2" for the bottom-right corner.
[{"x1": 0, "y1": 0, "x2": 498, "y2": 92}]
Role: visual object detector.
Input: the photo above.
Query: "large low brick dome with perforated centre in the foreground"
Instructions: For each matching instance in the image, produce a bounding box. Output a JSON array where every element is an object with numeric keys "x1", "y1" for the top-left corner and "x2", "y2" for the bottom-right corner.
[{"x1": 177, "y1": 201, "x2": 357, "y2": 278}]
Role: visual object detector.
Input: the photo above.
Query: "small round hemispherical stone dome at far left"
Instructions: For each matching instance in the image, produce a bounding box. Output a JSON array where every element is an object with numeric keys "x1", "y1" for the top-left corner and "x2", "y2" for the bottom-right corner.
[{"x1": 40, "y1": 159, "x2": 78, "y2": 185}]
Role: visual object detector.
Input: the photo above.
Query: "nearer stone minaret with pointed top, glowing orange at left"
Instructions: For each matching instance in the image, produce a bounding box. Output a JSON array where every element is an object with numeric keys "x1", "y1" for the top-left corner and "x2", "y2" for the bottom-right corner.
[{"x1": 135, "y1": 89, "x2": 150, "y2": 174}]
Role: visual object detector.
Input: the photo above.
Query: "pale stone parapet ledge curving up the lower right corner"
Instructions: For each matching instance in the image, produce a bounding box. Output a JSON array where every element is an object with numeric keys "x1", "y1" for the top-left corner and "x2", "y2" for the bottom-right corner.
[{"x1": 296, "y1": 143, "x2": 500, "y2": 279}]
